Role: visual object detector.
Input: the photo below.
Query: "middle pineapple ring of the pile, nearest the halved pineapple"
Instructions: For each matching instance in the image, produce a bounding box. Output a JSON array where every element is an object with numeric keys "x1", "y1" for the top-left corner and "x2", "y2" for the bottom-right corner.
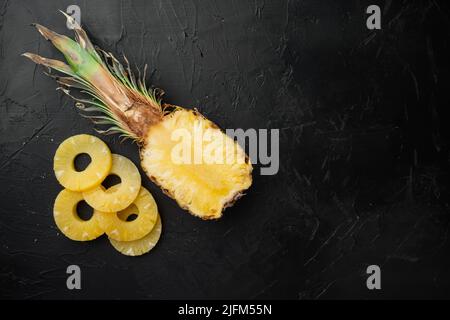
[{"x1": 83, "y1": 154, "x2": 141, "y2": 212}]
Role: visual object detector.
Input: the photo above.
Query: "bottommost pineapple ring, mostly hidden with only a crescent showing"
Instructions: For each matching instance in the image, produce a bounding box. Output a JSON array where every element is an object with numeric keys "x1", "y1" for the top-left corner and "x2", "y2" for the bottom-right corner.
[{"x1": 109, "y1": 214, "x2": 162, "y2": 256}]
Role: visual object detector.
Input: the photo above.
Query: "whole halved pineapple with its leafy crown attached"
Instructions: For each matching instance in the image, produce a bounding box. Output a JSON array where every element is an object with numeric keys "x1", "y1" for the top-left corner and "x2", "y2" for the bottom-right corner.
[{"x1": 24, "y1": 15, "x2": 252, "y2": 219}]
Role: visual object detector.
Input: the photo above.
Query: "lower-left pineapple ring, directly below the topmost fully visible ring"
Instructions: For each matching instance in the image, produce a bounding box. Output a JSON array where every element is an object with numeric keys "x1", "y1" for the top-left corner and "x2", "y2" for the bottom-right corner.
[{"x1": 53, "y1": 189, "x2": 104, "y2": 241}]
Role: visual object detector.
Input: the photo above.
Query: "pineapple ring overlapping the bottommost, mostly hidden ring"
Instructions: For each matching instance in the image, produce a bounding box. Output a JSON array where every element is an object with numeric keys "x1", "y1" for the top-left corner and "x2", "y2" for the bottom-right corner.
[{"x1": 98, "y1": 185, "x2": 158, "y2": 241}]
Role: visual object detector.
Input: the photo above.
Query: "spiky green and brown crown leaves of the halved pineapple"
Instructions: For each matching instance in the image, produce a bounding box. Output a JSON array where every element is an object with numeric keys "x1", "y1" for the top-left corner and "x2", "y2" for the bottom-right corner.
[{"x1": 23, "y1": 11, "x2": 165, "y2": 141}]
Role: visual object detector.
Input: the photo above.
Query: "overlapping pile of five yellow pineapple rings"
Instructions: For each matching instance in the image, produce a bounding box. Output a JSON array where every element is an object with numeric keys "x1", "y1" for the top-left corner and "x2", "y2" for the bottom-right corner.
[{"x1": 53, "y1": 134, "x2": 162, "y2": 256}]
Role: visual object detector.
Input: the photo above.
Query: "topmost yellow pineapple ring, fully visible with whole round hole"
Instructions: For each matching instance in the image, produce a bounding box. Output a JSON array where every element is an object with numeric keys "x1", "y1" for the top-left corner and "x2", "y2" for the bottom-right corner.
[{"x1": 53, "y1": 134, "x2": 112, "y2": 191}]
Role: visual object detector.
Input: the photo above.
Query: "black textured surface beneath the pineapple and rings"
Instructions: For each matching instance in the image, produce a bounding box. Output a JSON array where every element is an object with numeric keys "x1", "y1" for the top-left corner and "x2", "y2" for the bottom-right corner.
[{"x1": 0, "y1": 0, "x2": 450, "y2": 299}]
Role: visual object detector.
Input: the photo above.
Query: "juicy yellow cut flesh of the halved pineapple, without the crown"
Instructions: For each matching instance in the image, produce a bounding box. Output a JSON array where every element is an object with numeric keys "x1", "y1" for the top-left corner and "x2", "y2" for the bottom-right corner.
[{"x1": 140, "y1": 108, "x2": 253, "y2": 220}]
